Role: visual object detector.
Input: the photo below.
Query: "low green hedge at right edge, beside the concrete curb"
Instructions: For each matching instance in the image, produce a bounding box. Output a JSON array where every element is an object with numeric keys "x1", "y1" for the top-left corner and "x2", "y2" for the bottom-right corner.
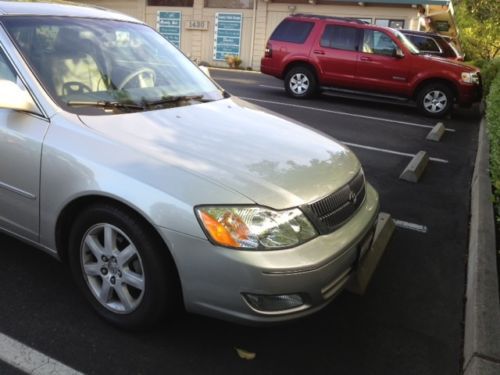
[{"x1": 486, "y1": 73, "x2": 500, "y2": 221}]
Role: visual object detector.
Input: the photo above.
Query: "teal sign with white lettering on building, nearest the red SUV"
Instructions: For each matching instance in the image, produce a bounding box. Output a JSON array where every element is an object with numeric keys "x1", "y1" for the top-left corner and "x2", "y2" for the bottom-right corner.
[{"x1": 214, "y1": 13, "x2": 243, "y2": 60}]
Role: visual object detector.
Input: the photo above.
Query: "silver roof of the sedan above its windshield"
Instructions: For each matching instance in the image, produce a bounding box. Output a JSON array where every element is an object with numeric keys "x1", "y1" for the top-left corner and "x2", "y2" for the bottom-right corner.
[{"x1": 0, "y1": 1, "x2": 141, "y2": 22}]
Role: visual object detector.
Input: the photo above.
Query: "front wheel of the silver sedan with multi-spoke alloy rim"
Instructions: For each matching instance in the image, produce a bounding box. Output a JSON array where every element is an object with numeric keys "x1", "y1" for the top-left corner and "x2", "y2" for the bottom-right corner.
[{"x1": 68, "y1": 204, "x2": 180, "y2": 329}]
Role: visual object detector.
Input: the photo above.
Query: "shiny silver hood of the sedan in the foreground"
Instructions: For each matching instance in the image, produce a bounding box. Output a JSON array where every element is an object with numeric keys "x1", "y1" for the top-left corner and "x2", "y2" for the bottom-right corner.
[{"x1": 80, "y1": 97, "x2": 360, "y2": 209}]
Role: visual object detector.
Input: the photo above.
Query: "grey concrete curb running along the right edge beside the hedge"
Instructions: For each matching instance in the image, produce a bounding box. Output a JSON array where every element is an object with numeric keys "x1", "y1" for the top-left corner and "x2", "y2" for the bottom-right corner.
[{"x1": 463, "y1": 118, "x2": 500, "y2": 375}]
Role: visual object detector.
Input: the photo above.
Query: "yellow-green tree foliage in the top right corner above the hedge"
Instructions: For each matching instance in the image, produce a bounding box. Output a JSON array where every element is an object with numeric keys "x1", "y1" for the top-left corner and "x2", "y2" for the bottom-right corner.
[{"x1": 455, "y1": 0, "x2": 500, "y2": 60}]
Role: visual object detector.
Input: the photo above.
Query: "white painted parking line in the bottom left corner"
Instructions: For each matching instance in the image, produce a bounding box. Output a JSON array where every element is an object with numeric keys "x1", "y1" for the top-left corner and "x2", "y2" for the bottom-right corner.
[{"x1": 0, "y1": 333, "x2": 83, "y2": 375}]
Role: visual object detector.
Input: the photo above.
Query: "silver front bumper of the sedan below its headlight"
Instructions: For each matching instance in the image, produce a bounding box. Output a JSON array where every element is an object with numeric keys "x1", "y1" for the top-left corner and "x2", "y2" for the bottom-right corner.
[{"x1": 159, "y1": 184, "x2": 379, "y2": 323}]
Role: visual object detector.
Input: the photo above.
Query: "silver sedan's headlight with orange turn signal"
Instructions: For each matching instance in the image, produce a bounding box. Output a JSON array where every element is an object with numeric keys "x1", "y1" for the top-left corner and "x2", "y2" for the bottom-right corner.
[{"x1": 195, "y1": 206, "x2": 318, "y2": 250}]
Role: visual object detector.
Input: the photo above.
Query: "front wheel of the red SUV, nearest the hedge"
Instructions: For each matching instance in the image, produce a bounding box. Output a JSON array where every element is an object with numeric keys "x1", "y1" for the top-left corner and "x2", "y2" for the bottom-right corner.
[{"x1": 417, "y1": 82, "x2": 455, "y2": 118}]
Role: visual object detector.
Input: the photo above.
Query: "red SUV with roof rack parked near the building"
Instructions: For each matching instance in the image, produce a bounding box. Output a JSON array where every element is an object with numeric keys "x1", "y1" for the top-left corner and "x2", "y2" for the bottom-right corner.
[{"x1": 261, "y1": 14, "x2": 481, "y2": 117}]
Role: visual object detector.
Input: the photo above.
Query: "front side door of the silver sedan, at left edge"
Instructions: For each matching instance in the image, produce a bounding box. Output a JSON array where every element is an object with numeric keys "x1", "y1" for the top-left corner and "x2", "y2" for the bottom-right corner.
[{"x1": 0, "y1": 46, "x2": 49, "y2": 241}]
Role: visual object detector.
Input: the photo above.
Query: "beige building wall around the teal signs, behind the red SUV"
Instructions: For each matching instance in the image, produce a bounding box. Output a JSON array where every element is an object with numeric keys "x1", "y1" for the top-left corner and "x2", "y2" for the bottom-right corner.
[{"x1": 79, "y1": 0, "x2": 417, "y2": 70}]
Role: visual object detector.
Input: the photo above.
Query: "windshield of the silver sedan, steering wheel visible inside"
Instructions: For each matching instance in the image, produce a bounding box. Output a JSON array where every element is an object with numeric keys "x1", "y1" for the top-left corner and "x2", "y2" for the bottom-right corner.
[{"x1": 2, "y1": 16, "x2": 224, "y2": 115}]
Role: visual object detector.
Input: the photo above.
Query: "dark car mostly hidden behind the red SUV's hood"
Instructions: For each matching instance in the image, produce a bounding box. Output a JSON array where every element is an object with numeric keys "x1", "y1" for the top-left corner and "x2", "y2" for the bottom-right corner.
[{"x1": 399, "y1": 30, "x2": 464, "y2": 61}]
